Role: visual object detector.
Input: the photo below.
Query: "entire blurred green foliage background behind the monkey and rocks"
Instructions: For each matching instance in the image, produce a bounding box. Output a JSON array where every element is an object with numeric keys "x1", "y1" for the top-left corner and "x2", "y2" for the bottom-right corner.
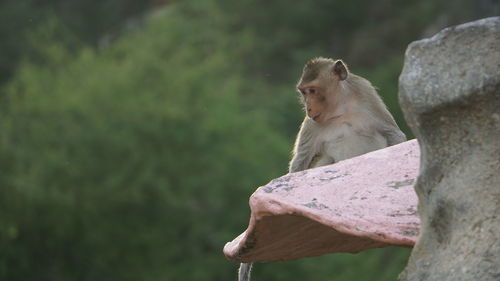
[{"x1": 0, "y1": 0, "x2": 494, "y2": 281}]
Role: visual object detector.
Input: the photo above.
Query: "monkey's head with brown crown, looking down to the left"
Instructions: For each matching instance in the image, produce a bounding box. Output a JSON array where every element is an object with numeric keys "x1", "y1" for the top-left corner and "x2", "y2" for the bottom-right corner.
[{"x1": 297, "y1": 58, "x2": 349, "y2": 124}]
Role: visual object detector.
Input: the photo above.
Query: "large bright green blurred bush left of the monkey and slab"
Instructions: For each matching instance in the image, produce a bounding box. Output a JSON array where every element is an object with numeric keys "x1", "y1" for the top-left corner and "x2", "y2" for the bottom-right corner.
[{"x1": 0, "y1": 4, "x2": 290, "y2": 280}]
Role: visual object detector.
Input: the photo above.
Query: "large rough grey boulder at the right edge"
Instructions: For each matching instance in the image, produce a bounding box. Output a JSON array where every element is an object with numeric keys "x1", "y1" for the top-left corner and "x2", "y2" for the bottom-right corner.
[{"x1": 399, "y1": 17, "x2": 500, "y2": 281}]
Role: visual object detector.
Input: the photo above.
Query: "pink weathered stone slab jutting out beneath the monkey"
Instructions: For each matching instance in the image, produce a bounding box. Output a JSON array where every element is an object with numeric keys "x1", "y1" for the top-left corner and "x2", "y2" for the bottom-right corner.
[{"x1": 224, "y1": 140, "x2": 420, "y2": 262}]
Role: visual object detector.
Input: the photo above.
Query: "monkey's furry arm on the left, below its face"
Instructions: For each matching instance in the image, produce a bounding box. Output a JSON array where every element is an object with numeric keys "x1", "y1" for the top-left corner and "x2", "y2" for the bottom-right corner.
[{"x1": 288, "y1": 117, "x2": 316, "y2": 173}]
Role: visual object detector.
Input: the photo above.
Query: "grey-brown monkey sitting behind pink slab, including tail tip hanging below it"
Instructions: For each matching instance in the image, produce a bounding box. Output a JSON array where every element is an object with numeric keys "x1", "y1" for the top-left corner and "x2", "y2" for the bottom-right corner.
[{"x1": 238, "y1": 57, "x2": 406, "y2": 281}]
